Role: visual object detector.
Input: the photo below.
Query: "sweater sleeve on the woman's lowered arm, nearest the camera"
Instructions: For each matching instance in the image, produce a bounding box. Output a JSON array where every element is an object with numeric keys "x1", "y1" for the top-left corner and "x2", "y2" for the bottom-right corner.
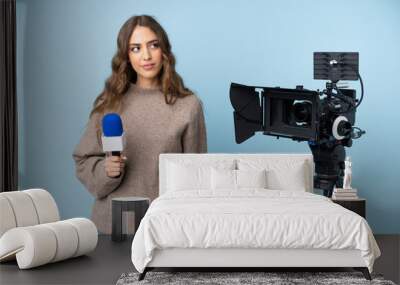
[{"x1": 182, "y1": 96, "x2": 207, "y2": 153}]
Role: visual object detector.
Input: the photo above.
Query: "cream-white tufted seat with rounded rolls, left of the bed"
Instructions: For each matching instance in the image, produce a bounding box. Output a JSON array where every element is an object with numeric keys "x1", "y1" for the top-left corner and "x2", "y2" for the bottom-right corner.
[{"x1": 0, "y1": 189, "x2": 98, "y2": 269}]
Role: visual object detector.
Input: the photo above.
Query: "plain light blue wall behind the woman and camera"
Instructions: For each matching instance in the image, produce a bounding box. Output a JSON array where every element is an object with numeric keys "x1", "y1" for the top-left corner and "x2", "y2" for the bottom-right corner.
[{"x1": 17, "y1": 0, "x2": 400, "y2": 233}]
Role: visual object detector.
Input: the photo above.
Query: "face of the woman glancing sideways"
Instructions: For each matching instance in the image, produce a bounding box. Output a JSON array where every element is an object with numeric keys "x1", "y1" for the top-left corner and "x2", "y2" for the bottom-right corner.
[{"x1": 128, "y1": 26, "x2": 162, "y2": 83}]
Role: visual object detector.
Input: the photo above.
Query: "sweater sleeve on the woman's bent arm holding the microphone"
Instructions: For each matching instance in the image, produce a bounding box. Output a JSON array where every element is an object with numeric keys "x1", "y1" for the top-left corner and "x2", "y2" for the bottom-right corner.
[{"x1": 72, "y1": 112, "x2": 124, "y2": 199}]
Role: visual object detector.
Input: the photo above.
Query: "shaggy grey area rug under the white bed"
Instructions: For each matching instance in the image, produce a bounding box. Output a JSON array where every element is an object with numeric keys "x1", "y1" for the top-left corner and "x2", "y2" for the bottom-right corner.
[{"x1": 117, "y1": 271, "x2": 395, "y2": 285}]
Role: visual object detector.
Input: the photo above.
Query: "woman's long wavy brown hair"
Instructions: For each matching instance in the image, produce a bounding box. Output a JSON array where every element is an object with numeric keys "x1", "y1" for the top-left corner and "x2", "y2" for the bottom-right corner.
[{"x1": 90, "y1": 15, "x2": 193, "y2": 126}]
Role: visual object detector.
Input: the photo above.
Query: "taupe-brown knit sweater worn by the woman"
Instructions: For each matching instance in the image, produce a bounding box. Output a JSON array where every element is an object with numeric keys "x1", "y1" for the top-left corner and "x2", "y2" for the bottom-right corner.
[{"x1": 73, "y1": 84, "x2": 207, "y2": 234}]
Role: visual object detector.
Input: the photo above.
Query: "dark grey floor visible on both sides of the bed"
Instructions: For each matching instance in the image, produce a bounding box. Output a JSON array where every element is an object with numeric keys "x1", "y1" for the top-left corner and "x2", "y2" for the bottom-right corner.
[{"x1": 0, "y1": 235, "x2": 400, "y2": 285}]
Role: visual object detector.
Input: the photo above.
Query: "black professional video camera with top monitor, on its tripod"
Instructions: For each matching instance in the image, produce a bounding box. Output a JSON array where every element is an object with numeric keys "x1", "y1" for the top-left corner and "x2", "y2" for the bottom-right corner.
[{"x1": 230, "y1": 53, "x2": 365, "y2": 197}]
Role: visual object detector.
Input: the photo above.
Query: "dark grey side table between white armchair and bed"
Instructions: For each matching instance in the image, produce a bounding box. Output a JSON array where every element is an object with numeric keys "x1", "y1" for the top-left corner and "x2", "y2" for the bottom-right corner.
[{"x1": 111, "y1": 197, "x2": 150, "y2": 241}]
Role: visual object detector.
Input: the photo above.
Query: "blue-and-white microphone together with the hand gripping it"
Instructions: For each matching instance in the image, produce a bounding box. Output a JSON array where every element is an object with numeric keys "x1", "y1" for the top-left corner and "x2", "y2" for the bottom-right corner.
[{"x1": 101, "y1": 113, "x2": 126, "y2": 177}]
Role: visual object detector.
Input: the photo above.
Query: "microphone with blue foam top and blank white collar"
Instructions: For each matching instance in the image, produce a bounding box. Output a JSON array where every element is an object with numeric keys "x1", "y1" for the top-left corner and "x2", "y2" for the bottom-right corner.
[{"x1": 101, "y1": 113, "x2": 124, "y2": 156}]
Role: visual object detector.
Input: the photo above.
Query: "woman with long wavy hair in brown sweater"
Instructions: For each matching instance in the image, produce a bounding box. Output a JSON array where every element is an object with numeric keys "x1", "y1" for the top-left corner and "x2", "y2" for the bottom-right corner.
[{"x1": 73, "y1": 15, "x2": 207, "y2": 234}]
